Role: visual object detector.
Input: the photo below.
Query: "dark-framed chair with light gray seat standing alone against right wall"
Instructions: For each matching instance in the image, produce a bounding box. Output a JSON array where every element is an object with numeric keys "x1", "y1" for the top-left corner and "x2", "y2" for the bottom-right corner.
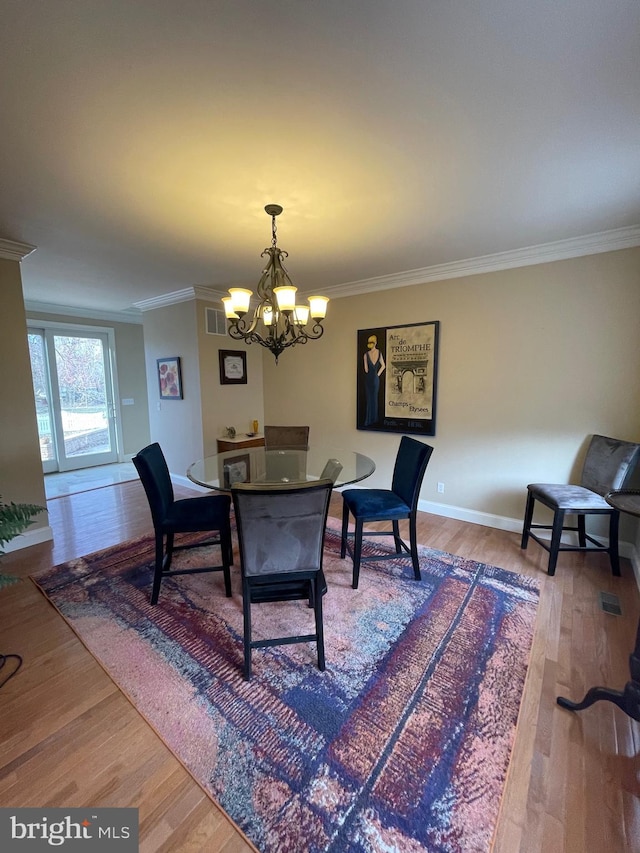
[{"x1": 520, "y1": 435, "x2": 640, "y2": 575}]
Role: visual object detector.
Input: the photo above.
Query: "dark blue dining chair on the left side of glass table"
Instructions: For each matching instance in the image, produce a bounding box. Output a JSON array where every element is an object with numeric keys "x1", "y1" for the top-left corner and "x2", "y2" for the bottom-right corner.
[{"x1": 132, "y1": 442, "x2": 233, "y2": 604}]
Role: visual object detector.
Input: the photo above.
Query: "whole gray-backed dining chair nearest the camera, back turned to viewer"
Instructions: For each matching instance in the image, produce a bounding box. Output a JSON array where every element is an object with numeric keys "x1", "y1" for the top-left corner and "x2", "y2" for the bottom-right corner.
[{"x1": 231, "y1": 479, "x2": 333, "y2": 681}]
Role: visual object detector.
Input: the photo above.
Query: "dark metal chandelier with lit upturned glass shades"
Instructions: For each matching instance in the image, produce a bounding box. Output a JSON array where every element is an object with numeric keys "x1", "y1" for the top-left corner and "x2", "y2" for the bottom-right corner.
[{"x1": 222, "y1": 204, "x2": 329, "y2": 364}]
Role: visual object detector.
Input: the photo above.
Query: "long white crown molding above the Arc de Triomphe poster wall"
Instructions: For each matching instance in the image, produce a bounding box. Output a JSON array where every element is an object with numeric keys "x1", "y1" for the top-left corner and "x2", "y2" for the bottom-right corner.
[{"x1": 322, "y1": 225, "x2": 640, "y2": 299}]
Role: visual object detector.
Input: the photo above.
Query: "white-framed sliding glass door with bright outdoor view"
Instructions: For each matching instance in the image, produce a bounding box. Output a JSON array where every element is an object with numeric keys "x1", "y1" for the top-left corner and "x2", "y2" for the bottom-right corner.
[{"x1": 29, "y1": 323, "x2": 118, "y2": 473}]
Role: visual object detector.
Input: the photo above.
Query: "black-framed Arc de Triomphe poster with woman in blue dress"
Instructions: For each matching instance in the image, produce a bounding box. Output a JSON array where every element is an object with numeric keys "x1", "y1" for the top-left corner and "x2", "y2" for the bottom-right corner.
[{"x1": 356, "y1": 320, "x2": 440, "y2": 435}]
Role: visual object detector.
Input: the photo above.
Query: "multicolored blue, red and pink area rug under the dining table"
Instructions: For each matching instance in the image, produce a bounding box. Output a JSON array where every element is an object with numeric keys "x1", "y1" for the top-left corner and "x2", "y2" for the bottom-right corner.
[{"x1": 33, "y1": 524, "x2": 538, "y2": 853}]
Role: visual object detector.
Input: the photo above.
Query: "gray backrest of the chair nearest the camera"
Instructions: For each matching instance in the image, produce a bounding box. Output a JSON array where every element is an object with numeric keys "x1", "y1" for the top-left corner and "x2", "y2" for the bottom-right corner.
[{"x1": 231, "y1": 480, "x2": 333, "y2": 577}]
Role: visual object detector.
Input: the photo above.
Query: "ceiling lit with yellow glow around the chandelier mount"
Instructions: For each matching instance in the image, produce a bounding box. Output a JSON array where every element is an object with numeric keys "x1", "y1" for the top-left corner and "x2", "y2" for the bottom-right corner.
[{"x1": 0, "y1": 0, "x2": 640, "y2": 311}]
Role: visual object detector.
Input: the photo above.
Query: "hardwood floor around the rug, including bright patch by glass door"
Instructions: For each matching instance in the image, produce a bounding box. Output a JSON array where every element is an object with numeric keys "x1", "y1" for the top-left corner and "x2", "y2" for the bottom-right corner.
[{"x1": 0, "y1": 481, "x2": 640, "y2": 853}]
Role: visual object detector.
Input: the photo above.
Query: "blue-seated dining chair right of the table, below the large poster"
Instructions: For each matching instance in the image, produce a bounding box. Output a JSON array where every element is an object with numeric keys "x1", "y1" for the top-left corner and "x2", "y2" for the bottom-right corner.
[{"x1": 340, "y1": 435, "x2": 433, "y2": 589}]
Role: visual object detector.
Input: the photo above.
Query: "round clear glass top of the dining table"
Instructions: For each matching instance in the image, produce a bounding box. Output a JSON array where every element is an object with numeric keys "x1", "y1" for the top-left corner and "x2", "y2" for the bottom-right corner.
[{"x1": 187, "y1": 444, "x2": 376, "y2": 491}]
